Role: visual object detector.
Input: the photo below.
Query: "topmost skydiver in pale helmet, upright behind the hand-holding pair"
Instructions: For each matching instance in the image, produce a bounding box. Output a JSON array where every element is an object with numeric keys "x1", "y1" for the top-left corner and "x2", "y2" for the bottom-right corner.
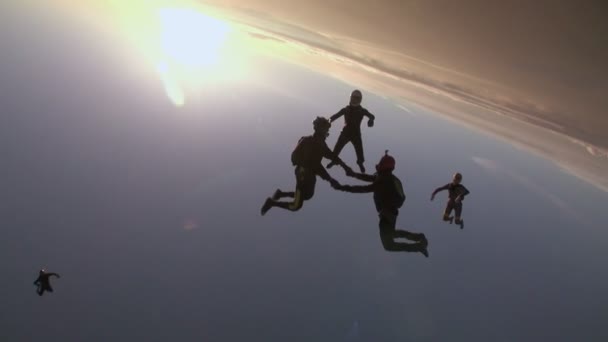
[{"x1": 327, "y1": 90, "x2": 375, "y2": 173}]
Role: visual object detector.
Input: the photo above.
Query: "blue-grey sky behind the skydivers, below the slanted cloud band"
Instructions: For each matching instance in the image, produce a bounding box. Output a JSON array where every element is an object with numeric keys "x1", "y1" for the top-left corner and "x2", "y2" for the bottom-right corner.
[{"x1": 0, "y1": 0, "x2": 608, "y2": 341}]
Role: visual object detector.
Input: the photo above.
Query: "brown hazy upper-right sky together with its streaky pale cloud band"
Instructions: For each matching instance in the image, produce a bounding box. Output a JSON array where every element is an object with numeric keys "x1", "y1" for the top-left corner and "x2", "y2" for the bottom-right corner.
[{"x1": 177, "y1": 1, "x2": 608, "y2": 190}]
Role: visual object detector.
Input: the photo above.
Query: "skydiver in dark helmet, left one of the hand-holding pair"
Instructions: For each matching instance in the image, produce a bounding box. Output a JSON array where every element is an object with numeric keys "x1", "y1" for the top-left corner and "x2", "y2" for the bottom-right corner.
[{"x1": 261, "y1": 116, "x2": 352, "y2": 215}]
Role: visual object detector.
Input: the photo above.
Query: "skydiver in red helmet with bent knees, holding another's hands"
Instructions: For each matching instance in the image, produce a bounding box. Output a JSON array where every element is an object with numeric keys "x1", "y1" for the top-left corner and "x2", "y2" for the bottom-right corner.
[{"x1": 336, "y1": 151, "x2": 429, "y2": 257}]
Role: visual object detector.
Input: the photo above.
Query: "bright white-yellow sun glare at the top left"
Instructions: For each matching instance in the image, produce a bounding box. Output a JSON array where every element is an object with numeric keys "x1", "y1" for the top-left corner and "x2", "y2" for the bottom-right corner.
[{"x1": 102, "y1": 0, "x2": 251, "y2": 106}]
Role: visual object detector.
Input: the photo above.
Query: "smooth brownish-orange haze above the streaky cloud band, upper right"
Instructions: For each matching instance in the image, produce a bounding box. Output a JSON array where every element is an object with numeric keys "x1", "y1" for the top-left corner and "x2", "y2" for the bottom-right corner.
[{"x1": 202, "y1": 0, "x2": 608, "y2": 147}]
